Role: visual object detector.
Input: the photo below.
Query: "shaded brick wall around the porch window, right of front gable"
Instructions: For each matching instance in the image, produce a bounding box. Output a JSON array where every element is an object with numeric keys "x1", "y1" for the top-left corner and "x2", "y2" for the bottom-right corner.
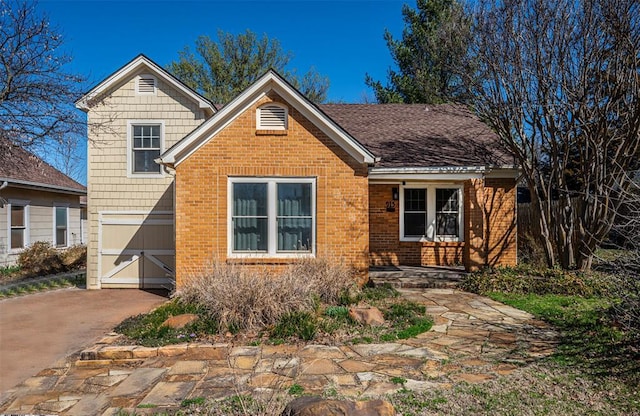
[{"x1": 369, "y1": 179, "x2": 516, "y2": 270}]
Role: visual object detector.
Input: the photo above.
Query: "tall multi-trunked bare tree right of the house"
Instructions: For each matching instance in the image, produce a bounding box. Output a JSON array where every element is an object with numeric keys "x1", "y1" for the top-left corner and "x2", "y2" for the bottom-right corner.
[{"x1": 469, "y1": 0, "x2": 640, "y2": 269}]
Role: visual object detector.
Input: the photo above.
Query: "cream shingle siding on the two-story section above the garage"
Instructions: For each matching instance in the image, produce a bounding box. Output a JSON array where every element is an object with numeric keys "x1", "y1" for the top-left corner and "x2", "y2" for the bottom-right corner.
[{"x1": 87, "y1": 69, "x2": 210, "y2": 288}]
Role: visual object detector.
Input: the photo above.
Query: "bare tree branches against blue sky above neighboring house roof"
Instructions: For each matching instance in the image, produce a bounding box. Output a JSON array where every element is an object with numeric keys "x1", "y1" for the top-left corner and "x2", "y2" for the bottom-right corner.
[{"x1": 0, "y1": 0, "x2": 85, "y2": 147}]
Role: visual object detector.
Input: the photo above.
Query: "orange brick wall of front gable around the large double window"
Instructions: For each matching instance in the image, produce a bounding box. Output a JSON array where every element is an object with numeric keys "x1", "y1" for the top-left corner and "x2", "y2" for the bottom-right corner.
[{"x1": 176, "y1": 93, "x2": 369, "y2": 287}]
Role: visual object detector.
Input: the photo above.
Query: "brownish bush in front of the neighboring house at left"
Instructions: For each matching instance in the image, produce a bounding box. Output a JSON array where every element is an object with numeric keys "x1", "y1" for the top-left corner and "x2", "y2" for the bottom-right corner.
[{"x1": 18, "y1": 241, "x2": 87, "y2": 277}]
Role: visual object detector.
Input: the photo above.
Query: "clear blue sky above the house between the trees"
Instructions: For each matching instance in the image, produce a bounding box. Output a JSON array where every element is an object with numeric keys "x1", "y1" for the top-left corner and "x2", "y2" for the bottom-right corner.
[{"x1": 39, "y1": 0, "x2": 404, "y2": 183}]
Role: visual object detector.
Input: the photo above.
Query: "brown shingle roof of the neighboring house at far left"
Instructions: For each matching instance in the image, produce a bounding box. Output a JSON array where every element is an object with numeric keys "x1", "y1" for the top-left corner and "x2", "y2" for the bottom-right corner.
[{"x1": 0, "y1": 137, "x2": 87, "y2": 193}]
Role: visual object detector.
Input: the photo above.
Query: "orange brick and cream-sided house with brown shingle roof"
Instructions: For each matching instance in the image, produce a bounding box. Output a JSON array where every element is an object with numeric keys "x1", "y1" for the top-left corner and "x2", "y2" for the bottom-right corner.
[{"x1": 76, "y1": 55, "x2": 517, "y2": 288}]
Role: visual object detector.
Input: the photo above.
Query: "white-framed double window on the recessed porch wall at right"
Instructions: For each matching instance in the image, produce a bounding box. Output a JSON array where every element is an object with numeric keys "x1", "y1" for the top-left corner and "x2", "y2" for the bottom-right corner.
[{"x1": 400, "y1": 185, "x2": 463, "y2": 241}]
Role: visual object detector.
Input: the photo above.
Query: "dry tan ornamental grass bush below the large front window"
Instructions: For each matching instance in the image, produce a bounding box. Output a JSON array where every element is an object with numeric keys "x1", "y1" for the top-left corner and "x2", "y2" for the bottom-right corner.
[{"x1": 176, "y1": 259, "x2": 354, "y2": 331}]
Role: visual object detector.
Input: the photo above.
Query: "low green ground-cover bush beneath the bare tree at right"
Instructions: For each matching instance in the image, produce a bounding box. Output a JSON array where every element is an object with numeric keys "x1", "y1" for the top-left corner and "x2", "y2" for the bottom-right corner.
[{"x1": 462, "y1": 265, "x2": 610, "y2": 297}]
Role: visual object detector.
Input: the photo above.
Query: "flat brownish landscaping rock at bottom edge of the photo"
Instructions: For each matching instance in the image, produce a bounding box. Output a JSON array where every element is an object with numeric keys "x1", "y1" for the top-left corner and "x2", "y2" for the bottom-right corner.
[{"x1": 282, "y1": 396, "x2": 396, "y2": 416}]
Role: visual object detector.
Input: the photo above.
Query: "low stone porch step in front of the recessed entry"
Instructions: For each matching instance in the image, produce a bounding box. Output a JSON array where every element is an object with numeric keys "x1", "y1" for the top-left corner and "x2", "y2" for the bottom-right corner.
[{"x1": 369, "y1": 266, "x2": 467, "y2": 289}]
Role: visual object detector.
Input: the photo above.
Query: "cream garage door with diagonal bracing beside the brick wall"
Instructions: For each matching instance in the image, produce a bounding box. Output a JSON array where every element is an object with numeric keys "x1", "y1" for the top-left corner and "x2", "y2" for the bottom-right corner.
[{"x1": 98, "y1": 212, "x2": 175, "y2": 289}]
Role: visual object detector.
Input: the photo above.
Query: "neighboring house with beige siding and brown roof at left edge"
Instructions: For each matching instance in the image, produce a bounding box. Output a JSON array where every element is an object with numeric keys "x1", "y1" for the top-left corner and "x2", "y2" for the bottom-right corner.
[{"x1": 0, "y1": 138, "x2": 87, "y2": 266}]
